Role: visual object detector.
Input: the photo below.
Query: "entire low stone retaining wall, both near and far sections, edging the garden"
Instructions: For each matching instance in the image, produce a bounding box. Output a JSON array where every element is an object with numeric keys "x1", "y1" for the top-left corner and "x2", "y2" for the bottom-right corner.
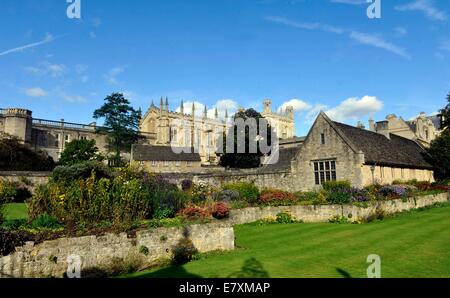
[{"x1": 0, "y1": 193, "x2": 449, "y2": 277}]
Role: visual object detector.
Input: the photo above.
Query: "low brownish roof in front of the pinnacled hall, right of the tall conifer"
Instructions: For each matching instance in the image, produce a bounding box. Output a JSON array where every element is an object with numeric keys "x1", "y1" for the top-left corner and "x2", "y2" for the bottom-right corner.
[{"x1": 131, "y1": 145, "x2": 201, "y2": 161}]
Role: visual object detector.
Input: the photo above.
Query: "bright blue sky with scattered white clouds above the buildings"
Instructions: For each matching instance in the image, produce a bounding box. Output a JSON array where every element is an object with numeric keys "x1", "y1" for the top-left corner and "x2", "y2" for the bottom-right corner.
[{"x1": 0, "y1": 0, "x2": 450, "y2": 135}]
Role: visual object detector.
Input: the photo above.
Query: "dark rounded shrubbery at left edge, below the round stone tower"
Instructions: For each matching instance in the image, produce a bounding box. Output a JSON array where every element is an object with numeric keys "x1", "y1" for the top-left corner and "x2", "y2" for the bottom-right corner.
[{"x1": 0, "y1": 135, "x2": 55, "y2": 171}]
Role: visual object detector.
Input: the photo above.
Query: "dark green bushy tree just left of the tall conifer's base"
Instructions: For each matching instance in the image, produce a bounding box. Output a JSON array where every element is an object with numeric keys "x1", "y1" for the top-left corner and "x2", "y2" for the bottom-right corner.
[{"x1": 59, "y1": 140, "x2": 102, "y2": 166}]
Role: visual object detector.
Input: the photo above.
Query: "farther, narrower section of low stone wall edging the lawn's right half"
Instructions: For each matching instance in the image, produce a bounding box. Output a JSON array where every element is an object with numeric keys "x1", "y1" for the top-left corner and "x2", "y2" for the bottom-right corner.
[{"x1": 227, "y1": 193, "x2": 449, "y2": 225}]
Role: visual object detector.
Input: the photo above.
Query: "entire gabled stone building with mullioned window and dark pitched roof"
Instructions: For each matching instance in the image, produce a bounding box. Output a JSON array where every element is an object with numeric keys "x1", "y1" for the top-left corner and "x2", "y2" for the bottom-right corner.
[{"x1": 292, "y1": 112, "x2": 434, "y2": 188}]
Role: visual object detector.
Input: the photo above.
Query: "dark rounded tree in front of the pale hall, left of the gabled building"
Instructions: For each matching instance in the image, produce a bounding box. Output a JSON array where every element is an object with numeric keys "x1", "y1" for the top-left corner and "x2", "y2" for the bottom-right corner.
[{"x1": 220, "y1": 109, "x2": 273, "y2": 169}]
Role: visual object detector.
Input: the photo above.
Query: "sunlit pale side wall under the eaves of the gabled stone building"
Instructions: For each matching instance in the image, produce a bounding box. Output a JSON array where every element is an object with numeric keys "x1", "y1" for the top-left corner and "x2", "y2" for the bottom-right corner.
[{"x1": 362, "y1": 165, "x2": 435, "y2": 186}]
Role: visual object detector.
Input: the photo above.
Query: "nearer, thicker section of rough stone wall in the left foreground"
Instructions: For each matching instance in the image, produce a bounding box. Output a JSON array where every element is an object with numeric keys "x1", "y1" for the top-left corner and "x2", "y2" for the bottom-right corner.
[{"x1": 0, "y1": 224, "x2": 234, "y2": 278}]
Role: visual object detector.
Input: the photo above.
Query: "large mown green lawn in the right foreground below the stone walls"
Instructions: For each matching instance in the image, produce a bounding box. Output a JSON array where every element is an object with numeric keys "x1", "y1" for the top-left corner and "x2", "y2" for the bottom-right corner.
[{"x1": 126, "y1": 204, "x2": 450, "y2": 278}]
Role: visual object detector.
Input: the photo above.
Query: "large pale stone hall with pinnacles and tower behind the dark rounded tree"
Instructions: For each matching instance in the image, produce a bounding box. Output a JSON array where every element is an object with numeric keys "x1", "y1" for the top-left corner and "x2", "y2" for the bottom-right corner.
[{"x1": 140, "y1": 97, "x2": 295, "y2": 165}]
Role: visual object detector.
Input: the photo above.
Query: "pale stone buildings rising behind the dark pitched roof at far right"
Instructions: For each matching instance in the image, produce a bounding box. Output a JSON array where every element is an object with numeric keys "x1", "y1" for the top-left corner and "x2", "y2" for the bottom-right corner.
[{"x1": 369, "y1": 113, "x2": 442, "y2": 147}]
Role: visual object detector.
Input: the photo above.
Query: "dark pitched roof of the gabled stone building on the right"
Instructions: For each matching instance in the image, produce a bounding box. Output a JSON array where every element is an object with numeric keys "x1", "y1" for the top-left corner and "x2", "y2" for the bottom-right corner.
[{"x1": 332, "y1": 122, "x2": 432, "y2": 169}]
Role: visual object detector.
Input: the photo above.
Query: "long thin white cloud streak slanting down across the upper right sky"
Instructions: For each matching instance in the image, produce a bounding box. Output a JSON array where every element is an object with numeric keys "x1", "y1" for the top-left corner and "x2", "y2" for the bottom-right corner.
[{"x1": 264, "y1": 16, "x2": 411, "y2": 59}]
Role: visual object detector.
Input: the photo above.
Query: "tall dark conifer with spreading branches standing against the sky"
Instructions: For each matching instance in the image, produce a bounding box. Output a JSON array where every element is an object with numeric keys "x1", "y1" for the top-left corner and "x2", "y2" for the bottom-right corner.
[{"x1": 94, "y1": 93, "x2": 142, "y2": 162}]
